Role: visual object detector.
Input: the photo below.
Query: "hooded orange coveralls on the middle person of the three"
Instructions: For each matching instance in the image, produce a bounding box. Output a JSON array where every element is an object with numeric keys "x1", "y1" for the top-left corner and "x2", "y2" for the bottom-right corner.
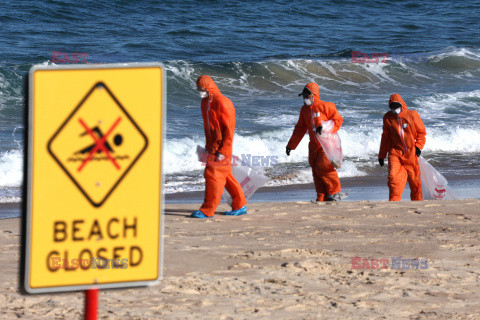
[{"x1": 287, "y1": 82, "x2": 343, "y2": 201}]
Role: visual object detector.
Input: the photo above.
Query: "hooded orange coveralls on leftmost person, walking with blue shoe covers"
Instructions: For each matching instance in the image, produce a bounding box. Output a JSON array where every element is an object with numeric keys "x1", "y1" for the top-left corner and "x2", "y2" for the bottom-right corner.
[{"x1": 197, "y1": 76, "x2": 247, "y2": 217}]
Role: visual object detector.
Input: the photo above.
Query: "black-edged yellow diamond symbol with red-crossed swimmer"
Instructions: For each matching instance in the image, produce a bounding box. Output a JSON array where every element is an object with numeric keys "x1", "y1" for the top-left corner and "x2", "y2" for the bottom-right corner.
[{"x1": 48, "y1": 82, "x2": 148, "y2": 207}]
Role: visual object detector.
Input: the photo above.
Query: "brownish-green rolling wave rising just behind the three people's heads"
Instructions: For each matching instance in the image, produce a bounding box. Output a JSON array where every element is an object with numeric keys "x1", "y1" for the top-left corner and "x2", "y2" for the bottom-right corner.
[{"x1": 164, "y1": 48, "x2": 480, "y2": 95}]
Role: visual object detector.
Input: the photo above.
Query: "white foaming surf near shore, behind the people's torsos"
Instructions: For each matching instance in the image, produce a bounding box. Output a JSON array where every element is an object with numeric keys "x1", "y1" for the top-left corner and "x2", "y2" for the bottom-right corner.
[{"x1": 0, "y1": 120, "x2": 480, "y2": 192}]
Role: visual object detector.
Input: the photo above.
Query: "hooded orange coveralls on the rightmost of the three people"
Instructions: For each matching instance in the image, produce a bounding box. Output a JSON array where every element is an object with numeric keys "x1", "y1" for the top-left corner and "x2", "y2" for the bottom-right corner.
[{"x1": 378, "y1": 94, "x2": 427, "y2": 201}]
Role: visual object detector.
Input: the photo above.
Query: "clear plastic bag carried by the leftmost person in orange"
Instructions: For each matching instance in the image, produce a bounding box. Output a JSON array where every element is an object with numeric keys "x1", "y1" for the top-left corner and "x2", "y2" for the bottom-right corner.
[{"x1": 197, "y1": 146, "x2": 269, "y2": 205}]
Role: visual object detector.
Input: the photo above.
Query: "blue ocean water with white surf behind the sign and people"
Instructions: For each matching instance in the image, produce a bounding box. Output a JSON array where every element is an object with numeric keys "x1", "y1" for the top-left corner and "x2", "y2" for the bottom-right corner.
[{"x1": 0, "y1": 0, "x2": 480, "y2": 202}]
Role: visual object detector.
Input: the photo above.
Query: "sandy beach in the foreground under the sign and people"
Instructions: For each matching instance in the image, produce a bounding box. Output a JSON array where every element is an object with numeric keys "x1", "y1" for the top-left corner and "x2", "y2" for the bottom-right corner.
[{"x1": 0, "y1": 200, "x2": 480, "y2": 319}]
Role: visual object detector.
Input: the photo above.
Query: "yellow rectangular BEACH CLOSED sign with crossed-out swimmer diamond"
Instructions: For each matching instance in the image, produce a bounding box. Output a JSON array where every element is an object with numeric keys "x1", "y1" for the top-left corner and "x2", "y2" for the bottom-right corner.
[{"x1": 24, "y1": 64, "x2": 165, "y2": 293}]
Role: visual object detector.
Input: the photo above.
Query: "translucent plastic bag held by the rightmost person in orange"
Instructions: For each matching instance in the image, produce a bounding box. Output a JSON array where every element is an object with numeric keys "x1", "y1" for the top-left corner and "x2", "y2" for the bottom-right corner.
[{"x1": 418, "y1": 157, "x2": 459, "y2": 200}]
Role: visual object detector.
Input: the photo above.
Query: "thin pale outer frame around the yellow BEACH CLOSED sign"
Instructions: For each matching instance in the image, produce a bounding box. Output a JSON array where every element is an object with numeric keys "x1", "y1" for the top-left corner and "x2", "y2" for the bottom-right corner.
[{"x1": 19, "y1": 62, "x2": 167, "y2": 294}]
